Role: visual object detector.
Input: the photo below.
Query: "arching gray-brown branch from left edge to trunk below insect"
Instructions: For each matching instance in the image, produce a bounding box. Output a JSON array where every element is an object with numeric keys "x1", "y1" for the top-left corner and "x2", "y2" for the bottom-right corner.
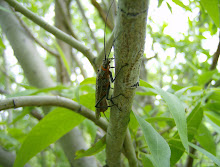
[{"x1": 0, "y1": 96, "x2": 107, "y2": 131}]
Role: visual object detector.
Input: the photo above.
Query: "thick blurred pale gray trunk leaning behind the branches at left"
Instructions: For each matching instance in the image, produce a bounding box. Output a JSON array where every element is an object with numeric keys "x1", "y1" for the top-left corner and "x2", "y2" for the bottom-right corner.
[{"x1": 0, "y1": 0, "x2": 96, "y2": 166}]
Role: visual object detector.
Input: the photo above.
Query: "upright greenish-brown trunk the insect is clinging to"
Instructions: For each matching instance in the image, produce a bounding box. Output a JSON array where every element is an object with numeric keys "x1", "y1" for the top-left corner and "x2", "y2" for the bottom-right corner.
[{"x1": 106, "y1": 0, "x2": 148, "y2": 167}]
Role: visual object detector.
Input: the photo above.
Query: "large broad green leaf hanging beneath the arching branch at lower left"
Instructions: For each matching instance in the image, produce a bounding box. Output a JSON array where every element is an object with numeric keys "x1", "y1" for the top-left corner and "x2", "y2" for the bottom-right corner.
[{"x1": 14, "y1": 108, "x2": 84, "y2": 167}]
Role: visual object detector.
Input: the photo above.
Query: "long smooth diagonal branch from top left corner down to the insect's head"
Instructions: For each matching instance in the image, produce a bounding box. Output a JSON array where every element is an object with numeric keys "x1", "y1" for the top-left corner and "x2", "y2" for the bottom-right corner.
[{"x1": 5, "y1": 0, "x2": 97, "y2": 70}]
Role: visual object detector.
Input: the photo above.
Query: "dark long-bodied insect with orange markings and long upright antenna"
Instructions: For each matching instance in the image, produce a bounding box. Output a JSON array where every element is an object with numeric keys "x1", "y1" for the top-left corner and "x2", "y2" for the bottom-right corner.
[{"x1": 95, "y1": 0, "x2": 126, "y2": 119}]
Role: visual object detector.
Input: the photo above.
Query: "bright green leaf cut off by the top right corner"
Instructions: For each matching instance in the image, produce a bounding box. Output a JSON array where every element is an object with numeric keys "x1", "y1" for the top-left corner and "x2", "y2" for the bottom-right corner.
[{"x1": 201, "y1": 0, "x2": 220, "y2": 27}]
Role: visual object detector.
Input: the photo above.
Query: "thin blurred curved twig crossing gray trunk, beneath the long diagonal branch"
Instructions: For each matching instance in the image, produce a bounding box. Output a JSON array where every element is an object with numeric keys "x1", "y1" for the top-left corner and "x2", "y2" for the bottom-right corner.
[{"x1": 15, "y1": 13, "x2": 60, "y2": 57}]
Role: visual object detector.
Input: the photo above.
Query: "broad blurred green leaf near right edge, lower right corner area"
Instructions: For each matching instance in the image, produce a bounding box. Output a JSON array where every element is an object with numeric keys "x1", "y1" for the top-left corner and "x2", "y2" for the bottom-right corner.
[{"x1": 195, "y1": 124, "x2": 216, "y2": 155}]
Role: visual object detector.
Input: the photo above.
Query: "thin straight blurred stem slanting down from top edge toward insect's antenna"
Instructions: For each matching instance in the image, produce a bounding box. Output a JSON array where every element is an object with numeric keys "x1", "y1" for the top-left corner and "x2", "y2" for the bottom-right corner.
[{"x1": 76, "y1": 0, "x2": 100, "y2": 53}]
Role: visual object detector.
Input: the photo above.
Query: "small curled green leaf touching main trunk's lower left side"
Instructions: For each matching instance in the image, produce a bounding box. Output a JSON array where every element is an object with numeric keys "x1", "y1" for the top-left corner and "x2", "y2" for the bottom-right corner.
[{"x1": 75, "y1": 136, "x2": 106, "y2": 159}]
